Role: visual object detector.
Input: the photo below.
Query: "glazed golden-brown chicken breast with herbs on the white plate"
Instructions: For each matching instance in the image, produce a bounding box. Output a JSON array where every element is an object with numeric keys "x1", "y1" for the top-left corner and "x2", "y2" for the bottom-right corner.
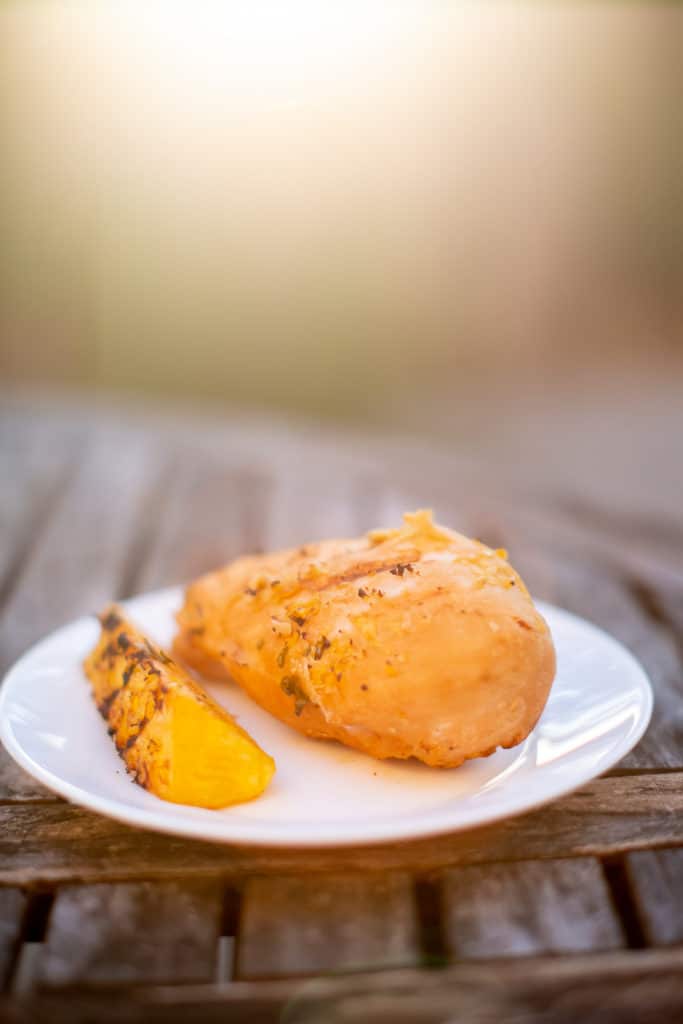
[{"x1": 175, "y1": 511, "x2": 555, "y2": 767}]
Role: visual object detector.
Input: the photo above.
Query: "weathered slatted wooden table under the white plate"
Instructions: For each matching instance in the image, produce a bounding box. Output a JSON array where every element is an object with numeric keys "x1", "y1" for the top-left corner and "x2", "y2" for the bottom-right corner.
[{"x1": 0, "y1": 401, "x2": 683, "y2": 1024}]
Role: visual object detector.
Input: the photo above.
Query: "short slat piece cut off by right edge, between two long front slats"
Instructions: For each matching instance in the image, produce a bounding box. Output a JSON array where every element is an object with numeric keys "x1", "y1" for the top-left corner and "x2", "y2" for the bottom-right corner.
[{"x1": 626, "y1": 850, "x2": 683, "y2": 946}]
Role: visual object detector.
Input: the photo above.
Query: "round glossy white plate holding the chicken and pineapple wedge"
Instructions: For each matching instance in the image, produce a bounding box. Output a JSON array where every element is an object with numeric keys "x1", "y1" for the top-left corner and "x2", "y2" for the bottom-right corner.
[{"x1": 0, "y1": 589, "x2": 652, "y2": 846}]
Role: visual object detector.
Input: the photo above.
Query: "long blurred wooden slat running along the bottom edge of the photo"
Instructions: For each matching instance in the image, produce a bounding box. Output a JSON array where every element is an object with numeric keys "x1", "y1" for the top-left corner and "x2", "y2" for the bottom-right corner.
[{"x1": 0, "y1": 949, "x2": 683, "y2": 1024}]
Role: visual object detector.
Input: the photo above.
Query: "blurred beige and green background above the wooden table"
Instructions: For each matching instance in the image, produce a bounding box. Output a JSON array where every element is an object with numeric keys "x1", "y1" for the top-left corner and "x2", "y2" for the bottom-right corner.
[{"x1": 0, "y1": 6, "x2": 683, "y2": 520}]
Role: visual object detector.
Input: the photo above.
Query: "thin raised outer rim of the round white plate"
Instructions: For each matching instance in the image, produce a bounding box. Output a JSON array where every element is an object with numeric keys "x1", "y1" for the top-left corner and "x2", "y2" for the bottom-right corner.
[{"x1": 0, "y1": 586, "x2": 654, "y2": 850}]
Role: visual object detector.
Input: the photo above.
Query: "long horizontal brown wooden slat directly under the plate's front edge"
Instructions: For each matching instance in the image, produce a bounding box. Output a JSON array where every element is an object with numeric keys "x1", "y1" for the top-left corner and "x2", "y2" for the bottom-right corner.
[{"x1": 0, "y1": 772, "x2": 683, "y2": 885}]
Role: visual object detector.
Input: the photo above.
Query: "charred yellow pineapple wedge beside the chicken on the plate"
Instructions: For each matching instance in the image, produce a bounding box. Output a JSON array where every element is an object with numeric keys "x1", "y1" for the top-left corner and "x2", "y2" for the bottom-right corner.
[{"x1": 84, "y1": 605, "x2": 275, "y2": 808}]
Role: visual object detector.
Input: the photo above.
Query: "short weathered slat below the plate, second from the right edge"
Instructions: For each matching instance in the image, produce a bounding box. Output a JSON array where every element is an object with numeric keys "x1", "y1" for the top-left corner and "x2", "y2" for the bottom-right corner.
[{"x1": 441, "y1": 858, "x2": 624, "y2": 958}]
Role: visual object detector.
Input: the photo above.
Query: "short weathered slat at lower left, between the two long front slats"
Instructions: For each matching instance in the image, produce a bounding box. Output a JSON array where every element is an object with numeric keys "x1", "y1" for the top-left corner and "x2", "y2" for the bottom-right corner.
[{"x1": 41, "y1": 882, "x2": 222, "y2": 986}]
